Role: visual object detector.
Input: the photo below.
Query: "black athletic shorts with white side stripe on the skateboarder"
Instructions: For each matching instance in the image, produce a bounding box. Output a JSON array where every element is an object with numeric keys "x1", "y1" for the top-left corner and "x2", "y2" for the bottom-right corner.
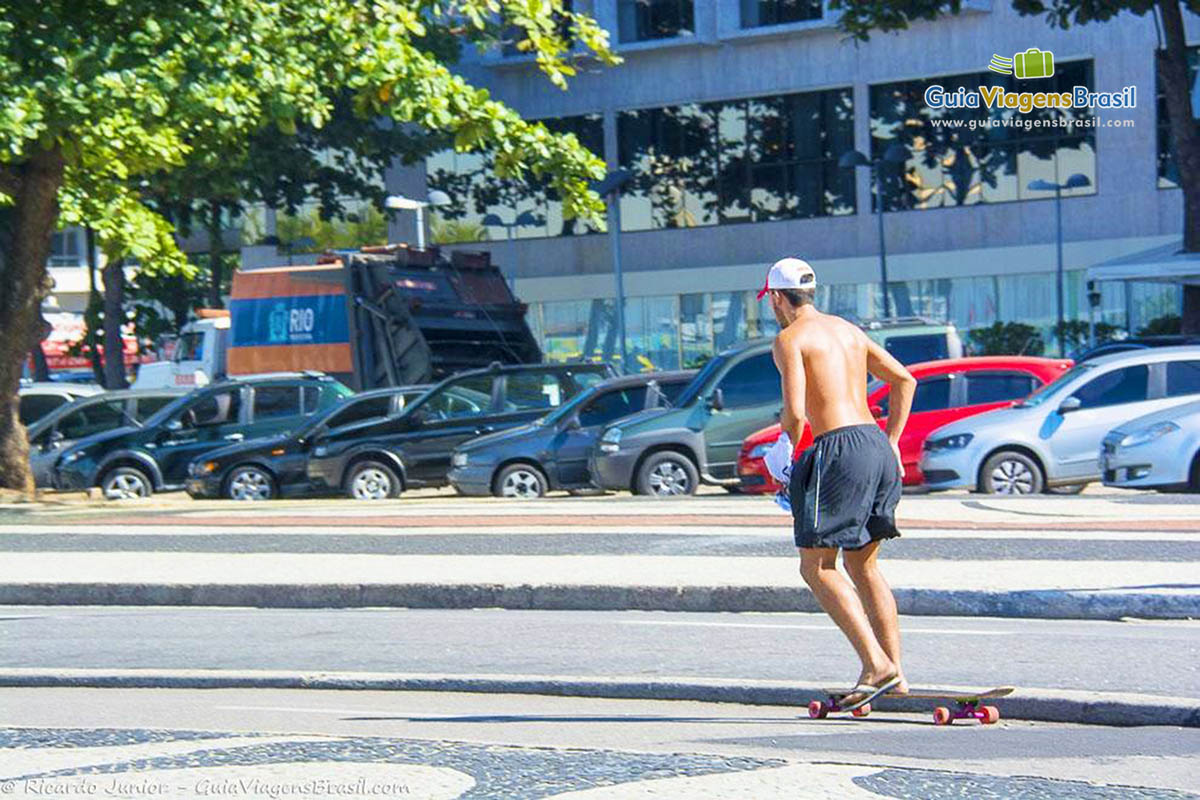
[{"x1": 788, "y1": 423, "x2": 900, "y2": 551}]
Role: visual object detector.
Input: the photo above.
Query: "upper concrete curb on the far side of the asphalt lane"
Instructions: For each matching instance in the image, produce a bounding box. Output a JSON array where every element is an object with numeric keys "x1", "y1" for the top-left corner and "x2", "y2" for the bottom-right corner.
[{"x1": 0, "y1": 583, "x2": 1200, "y2": 620}]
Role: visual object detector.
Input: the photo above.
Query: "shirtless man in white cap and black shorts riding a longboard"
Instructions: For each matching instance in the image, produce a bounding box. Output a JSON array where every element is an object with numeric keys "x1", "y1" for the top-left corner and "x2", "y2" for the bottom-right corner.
[{"x1": 758, "y1": 258, "x2": 917, "y2": 710}]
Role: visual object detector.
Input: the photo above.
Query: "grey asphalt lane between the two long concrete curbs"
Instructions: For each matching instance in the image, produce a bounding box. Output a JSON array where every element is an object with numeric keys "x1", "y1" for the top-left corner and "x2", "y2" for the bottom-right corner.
[{"x1": 0, "y1": 607, "x2": 1200, "y2": 697}]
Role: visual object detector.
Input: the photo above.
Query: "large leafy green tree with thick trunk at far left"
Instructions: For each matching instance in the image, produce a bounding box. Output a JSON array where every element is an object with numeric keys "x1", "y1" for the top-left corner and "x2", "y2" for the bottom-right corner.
[{"x1": 0, "y1": 0, "x2": 616, "y2": 491}]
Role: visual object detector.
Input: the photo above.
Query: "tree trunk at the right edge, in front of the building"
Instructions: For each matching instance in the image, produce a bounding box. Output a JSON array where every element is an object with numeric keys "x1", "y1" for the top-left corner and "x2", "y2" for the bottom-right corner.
[{"x1": 1158, "y1": 0, "x2": 1200, "y2": 333}]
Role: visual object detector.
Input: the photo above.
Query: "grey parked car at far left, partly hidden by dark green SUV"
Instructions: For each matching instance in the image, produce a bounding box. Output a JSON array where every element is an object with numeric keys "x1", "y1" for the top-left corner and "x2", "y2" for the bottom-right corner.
[{"x1": 26, "y1": 389, "x2": 187, "y2": 487}]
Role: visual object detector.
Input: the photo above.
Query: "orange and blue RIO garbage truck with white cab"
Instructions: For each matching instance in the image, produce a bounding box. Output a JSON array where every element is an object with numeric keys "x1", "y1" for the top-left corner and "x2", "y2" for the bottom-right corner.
[{"x1": 134, "y1": 245, "x2": 542, "y2": 391}]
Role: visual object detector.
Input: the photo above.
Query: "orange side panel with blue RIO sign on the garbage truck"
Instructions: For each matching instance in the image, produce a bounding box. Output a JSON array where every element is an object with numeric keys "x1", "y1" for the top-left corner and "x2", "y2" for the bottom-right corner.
[{"x1": 229, "y1": 267, "x2": 353, "y2": 374}]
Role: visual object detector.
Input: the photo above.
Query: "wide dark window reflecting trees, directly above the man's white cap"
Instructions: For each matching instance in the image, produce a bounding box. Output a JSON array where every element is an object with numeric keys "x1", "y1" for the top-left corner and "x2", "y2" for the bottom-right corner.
[{"x1": 617, "y1": 89, "x2": 854, "y2": 230}]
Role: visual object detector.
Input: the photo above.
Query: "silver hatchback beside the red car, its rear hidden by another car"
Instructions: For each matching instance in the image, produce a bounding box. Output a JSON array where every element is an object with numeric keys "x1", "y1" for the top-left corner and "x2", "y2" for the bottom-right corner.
[{"x1": 920, "y1": 347, "x2": 1200, "y2": 494}]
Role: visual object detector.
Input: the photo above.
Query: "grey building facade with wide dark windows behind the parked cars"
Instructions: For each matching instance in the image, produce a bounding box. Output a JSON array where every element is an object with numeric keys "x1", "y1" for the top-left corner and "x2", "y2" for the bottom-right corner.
[{"x1": 390, "y1": 0, "x2": 1200, "y2": 368}]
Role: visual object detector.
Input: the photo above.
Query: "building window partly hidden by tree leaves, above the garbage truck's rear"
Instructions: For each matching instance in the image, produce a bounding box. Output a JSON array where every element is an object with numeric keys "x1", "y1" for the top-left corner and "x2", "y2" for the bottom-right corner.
[{"x1": 425, "y1": 114, "x2": 604, "y2": 243}]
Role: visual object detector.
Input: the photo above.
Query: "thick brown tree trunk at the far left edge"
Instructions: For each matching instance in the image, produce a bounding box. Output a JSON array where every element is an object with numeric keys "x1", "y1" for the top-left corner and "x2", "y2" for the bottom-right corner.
[{"x1": 0, "y1": 148, "x2": 62, "y2": 494}]
